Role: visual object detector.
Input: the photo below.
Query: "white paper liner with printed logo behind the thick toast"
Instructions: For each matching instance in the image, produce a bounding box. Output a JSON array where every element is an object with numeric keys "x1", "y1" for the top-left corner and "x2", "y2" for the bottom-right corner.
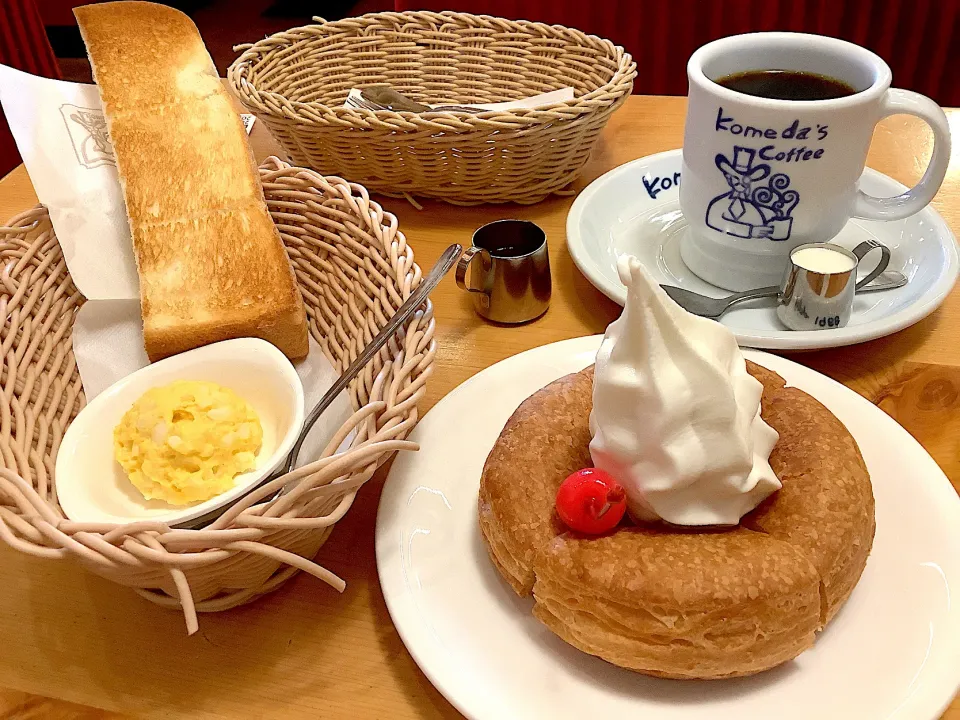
[{"x1": 0, "y1": 65, "x2": 353, "y2": 464}]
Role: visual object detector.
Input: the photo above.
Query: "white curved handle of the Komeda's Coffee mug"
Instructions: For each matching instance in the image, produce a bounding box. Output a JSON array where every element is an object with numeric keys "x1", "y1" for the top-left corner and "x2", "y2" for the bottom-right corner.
[{"x1": 853, "y1": 88, "x2": 950, "y2": 220}]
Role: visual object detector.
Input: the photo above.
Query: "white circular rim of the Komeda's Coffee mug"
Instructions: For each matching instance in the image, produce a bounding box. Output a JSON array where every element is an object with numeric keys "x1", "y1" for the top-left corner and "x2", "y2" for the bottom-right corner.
[{"x1": 687, "y1": 32, "x2": 893, "y2": 110}]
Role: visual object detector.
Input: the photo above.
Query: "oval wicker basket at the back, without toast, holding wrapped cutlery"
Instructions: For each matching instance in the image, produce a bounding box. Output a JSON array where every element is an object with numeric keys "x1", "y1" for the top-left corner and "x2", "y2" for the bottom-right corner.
[{"x1": 227, "y1": 12, "x2": 636, "y2": 205}]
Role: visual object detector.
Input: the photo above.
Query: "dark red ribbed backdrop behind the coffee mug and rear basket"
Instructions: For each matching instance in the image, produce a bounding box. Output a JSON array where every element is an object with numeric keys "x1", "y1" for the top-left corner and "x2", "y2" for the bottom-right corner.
[{"x1": 394, "y1": 0, "x2": 960, "y2": 106}]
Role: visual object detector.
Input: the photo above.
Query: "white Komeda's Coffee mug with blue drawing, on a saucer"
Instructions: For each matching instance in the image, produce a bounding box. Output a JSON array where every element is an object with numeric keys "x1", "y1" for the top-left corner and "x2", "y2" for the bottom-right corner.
[{"x1": 680, "y1": 33, "x2": 950, "y2": 290}]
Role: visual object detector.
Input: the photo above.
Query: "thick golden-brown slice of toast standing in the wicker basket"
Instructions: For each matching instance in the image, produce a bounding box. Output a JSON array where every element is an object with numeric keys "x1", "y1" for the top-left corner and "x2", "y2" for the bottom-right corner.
[{"x1": 74, "y1": 2, "x2": 307, "y2": 360}]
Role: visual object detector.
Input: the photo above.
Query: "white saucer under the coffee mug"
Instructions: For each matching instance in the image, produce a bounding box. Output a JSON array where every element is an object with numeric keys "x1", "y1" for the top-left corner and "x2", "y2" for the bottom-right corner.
[{"x1": 567, "y1": 150, "x2": 960, "y2": 350}]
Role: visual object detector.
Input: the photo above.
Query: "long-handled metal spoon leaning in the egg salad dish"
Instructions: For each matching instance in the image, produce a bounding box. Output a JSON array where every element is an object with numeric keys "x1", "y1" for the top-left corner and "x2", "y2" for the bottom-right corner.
[{"x1": 174, "y1": 244, "x2": 463, "y2": 530}]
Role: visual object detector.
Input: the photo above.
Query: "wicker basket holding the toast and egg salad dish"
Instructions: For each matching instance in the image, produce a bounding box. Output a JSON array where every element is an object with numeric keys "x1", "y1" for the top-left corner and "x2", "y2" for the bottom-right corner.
[{"x1": 0, "y1": 158, "x2": 436, "y2": 632}]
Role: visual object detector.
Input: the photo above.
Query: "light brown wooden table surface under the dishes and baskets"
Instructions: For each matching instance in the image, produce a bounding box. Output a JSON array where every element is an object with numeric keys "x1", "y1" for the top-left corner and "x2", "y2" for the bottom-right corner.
[{"x1": 0, "y1": 97, "x2": 960, "y2": 720}]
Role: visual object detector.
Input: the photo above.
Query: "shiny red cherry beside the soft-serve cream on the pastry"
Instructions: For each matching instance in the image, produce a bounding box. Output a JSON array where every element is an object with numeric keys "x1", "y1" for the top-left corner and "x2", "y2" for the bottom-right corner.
[{"x1": 557, "y1": 468, "x2": 627, "y2": 535}]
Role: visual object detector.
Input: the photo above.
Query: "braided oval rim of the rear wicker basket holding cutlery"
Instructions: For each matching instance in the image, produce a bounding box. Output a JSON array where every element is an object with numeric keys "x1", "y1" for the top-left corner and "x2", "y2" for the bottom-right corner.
[{"x1": 227, "y1": 10, "x2": 636, "y2": 126}]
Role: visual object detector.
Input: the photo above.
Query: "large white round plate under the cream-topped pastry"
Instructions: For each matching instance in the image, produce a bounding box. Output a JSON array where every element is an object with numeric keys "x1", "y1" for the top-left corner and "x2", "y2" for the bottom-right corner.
[{"x1": 376, "y1": 336, "x2": 960, "y2": 720}]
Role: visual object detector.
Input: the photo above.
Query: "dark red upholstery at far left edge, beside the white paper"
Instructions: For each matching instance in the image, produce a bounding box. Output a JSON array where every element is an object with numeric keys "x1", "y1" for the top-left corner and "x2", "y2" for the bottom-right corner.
[{"x1": 0, "y1": 0, "x2": 60, "y2": 177}]
